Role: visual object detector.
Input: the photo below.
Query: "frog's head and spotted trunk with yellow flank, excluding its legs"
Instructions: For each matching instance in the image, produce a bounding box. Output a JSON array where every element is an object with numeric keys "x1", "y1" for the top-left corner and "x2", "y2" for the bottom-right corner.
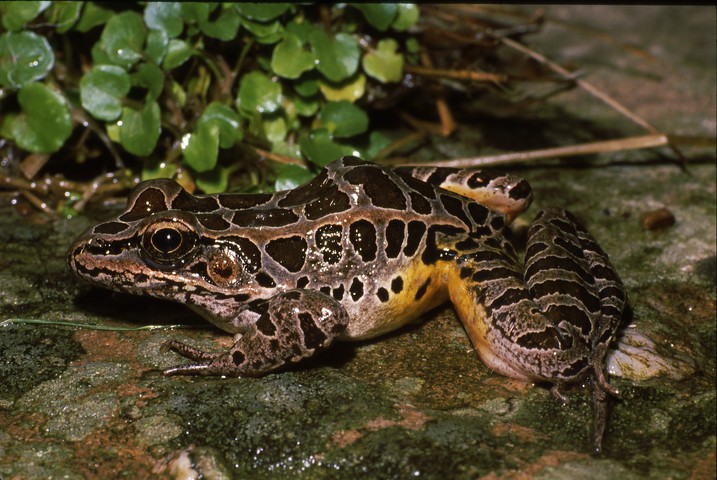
[{"x1": 68, "y1": 157, "x2": 506, "y2": 337}]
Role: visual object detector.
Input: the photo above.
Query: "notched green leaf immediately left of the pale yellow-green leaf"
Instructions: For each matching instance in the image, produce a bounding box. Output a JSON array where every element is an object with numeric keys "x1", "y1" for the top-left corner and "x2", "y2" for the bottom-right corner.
[{"x1": 309, "y1": 29, "x2": 361, "y2": 82}]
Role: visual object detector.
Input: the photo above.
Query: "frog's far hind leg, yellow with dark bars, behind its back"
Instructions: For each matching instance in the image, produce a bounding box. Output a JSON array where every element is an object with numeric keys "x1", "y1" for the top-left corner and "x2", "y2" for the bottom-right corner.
[{"x1": 394, "y1": 167, "x2": 533, "y2": 222}]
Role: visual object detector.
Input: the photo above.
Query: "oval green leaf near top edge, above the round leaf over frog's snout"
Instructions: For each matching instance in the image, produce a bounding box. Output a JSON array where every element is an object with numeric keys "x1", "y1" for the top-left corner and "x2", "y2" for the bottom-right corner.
[{"x1": 99, "y1": 11, "x2": 147, "y2": 70}]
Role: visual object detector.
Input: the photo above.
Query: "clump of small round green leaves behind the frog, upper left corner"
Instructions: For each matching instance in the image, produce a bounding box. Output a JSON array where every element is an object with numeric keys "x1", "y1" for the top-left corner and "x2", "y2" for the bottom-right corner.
[{"x1": 0, "y1": 1, "x2": 419, "y2": 197}]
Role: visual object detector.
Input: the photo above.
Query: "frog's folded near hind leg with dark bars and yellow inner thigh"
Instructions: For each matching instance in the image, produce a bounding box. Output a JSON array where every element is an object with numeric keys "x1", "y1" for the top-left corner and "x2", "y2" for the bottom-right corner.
[{"x1": 449, "y1": 209, "x2": 626, "y2": 450}]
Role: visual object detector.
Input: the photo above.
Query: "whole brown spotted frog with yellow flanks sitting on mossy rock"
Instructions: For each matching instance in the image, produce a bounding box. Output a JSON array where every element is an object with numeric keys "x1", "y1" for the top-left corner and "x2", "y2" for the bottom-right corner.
[{"x1": 67, "y1": 157, "x2": 626, "y2": 449}]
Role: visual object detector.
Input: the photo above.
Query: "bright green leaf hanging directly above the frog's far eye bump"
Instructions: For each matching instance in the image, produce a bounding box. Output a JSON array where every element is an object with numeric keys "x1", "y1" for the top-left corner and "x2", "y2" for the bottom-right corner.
[{"x1": 119, "y1": 102, "x2": 161, "y2": 156}]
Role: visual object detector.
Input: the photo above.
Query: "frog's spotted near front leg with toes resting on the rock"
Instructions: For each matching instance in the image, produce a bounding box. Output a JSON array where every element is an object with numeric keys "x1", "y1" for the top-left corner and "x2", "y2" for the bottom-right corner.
[{"x1": 164, "y1": 290, "x2": 348, "y2": 377}]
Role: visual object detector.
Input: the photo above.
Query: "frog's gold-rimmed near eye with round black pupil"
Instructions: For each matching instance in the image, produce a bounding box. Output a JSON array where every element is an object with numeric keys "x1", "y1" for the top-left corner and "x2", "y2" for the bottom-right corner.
[{"x1": 141, "y1": 220, "x2": 198, "y2": 268}]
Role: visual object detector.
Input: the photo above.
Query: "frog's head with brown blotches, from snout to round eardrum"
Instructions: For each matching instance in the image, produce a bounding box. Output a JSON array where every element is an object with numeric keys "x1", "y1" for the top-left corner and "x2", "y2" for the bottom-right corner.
[{"x1": 67, "y1": 179, "x2": 261, "y2": 303}]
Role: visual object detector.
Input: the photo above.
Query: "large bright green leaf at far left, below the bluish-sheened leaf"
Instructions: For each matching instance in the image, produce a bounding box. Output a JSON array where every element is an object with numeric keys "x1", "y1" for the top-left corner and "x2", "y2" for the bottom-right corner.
[{"x1": 11, "y1": 83, "x2": 72, "y2": 153}]
